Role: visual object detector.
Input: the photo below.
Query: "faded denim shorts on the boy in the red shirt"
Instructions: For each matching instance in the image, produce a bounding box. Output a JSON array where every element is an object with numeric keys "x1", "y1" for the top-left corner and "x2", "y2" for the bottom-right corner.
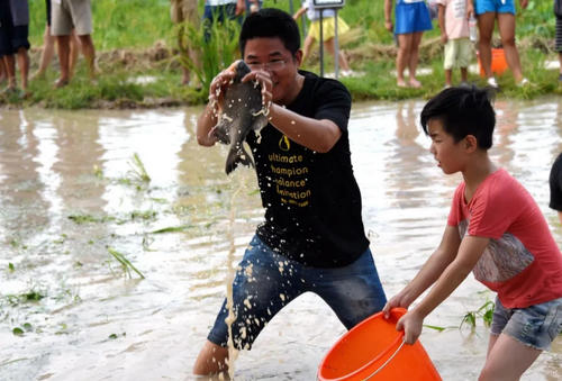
[{"x1": 491, "y1": 298, "x2": 562, "y2": 350}]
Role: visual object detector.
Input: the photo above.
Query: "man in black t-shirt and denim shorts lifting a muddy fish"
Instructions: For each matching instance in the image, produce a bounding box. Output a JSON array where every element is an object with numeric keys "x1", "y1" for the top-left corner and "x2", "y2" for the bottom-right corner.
[{"x1": 193, "y1": 8, "x2": 386, "y2": 375}]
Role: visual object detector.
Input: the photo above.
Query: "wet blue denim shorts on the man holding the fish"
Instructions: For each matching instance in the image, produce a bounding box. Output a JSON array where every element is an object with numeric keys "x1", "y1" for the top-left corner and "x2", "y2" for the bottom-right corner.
[{"x1": 207, "y1": 236, "x2": 386, "y2": 349}]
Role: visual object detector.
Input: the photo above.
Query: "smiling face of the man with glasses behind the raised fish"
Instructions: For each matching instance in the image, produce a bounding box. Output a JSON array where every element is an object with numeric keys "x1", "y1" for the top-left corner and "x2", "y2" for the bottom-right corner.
[{"x1": 244, "y1": 37, "x2": 302, "y2": 104}]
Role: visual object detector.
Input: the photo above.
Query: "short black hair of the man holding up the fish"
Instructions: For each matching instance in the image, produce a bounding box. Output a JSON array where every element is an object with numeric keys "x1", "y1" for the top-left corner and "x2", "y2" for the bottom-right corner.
[{"x1": 239, "y1": 8, "x2": 301, "y2": 57}]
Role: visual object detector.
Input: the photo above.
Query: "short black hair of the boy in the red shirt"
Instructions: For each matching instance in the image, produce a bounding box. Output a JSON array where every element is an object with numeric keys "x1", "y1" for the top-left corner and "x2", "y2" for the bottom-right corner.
[{"x1": 420, "y1": 86, "x2": 496, "y2": 150}]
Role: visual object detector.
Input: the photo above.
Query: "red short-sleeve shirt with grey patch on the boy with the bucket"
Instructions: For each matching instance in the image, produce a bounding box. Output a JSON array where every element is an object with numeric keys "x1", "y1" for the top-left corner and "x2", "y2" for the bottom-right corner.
[{"x1": 447, "y1": 169, "x2": 562, "y2": 308}]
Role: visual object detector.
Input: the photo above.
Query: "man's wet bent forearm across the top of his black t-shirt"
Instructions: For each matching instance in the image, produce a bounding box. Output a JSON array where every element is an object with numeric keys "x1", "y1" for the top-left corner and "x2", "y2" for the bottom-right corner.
[{"x1": 269, "y1": 104, "x2": 342, "y2": 153}]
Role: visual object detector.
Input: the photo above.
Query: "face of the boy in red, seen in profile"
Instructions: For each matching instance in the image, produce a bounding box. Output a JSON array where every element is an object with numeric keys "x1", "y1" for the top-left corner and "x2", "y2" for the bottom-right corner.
[{"x1": 427, "y1": 118, "x2": 465, "y2": 174}]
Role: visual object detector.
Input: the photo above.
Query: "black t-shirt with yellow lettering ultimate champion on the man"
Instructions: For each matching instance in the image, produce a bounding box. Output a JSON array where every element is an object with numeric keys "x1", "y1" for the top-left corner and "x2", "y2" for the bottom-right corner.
[{"x1": 248, "y1": 71, "x2": 369, "y2": 268}]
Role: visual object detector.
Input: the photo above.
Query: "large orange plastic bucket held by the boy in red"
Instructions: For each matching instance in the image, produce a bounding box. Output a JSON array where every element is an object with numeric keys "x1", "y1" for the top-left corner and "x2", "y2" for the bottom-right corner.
[{"x1": 318, "y1": 308, "x2": 442, "y2": 381}]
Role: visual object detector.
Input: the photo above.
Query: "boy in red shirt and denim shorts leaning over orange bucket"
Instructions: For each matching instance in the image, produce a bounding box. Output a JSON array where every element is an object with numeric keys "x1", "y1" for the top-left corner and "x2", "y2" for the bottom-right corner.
[{"x1": 384, "y1": 88, "x2": 562, "y2": 380}]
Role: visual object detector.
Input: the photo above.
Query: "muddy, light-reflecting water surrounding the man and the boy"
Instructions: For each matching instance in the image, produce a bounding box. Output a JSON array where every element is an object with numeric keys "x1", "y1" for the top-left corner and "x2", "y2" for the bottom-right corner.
[{"x1": 0, "y1": 99, "x2": 562, "y2": 380}]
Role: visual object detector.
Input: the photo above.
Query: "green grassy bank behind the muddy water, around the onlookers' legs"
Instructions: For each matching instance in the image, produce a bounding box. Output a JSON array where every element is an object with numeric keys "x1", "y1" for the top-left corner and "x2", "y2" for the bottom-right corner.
[{"x1": 0, "y1": 0, "x2": 561, "y2": 109}]
